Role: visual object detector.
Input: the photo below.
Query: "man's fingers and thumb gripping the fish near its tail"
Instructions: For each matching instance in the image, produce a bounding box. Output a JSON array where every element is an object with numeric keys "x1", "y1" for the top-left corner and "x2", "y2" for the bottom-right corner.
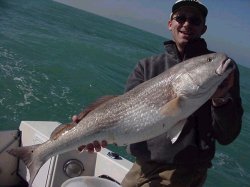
[{"x1": 72, "y1": 115, "x2": 108, "y2": 153}]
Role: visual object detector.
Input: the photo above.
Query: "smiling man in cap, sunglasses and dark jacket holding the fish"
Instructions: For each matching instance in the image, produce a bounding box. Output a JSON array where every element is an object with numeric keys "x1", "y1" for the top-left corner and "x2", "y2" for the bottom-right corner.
[{"x1": 73, "y1": 0, "x2": 243, "y2": 187}]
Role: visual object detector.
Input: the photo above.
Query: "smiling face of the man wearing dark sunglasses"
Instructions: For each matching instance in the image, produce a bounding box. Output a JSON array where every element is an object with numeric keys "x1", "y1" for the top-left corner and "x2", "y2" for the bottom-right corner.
[{"x1": 168, "y1": 7, "x2": 207, "y2": 47}]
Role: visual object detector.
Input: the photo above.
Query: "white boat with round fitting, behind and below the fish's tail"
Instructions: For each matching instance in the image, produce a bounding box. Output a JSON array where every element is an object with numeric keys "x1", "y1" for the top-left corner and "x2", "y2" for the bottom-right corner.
[{"x1": 0, "y1": 121, "x2": 132, "y2": 187}]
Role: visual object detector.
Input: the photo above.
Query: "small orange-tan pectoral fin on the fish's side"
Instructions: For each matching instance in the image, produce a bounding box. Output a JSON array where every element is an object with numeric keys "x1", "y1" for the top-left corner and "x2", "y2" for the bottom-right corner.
[{"x1": 160, "y1": 96, "x2": 181, "y2": 116}]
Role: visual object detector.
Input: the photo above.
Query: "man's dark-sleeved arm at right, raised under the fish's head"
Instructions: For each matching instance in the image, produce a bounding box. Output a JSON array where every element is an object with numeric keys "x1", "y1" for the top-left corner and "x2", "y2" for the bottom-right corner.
[{"x1": 211, "y1": 67, "x2": 243, "y2": 145}]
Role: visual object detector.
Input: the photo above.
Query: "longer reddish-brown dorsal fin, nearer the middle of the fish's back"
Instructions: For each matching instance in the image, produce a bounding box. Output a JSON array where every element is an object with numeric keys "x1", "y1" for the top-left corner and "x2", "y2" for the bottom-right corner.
[{"x1": 77, "y1": 95, "x2": 117, "y2": 121}]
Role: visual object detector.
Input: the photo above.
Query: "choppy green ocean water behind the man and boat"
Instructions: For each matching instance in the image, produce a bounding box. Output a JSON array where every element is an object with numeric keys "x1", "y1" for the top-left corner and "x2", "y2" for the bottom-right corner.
[{"x1": 0, "y1": 0, "x2": 250, "y2": 187}]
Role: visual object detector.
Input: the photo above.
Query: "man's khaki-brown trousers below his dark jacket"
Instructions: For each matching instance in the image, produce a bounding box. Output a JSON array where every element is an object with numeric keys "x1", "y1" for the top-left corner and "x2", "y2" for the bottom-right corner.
[{"x1": 122, "y1": 163, "x2": 207, "y2": 187}]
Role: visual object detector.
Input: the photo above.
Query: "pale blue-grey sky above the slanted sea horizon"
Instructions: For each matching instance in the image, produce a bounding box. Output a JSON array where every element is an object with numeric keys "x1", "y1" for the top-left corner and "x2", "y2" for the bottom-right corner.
[{"x1": 56, "y1": 0, "x2": 250, "y2": 67}]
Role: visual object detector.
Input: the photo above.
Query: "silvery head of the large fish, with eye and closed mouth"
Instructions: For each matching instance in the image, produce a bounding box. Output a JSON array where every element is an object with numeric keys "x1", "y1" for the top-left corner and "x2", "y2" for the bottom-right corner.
[{"x1": 176, "y1": 53, "x2": 235, "y2": 97}]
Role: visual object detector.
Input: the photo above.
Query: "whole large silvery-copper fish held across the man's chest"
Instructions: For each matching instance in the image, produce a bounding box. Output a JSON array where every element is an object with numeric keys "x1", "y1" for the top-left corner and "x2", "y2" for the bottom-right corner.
[{"x1": 9, "y1": 53, "x2": 234, "y2": 186}]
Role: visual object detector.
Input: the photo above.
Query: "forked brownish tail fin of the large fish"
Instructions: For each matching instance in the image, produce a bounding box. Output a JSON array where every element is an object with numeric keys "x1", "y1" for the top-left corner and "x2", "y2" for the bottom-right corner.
[{"x1": 7, "y1": 144, "x2": 44, "y2": 187}]
